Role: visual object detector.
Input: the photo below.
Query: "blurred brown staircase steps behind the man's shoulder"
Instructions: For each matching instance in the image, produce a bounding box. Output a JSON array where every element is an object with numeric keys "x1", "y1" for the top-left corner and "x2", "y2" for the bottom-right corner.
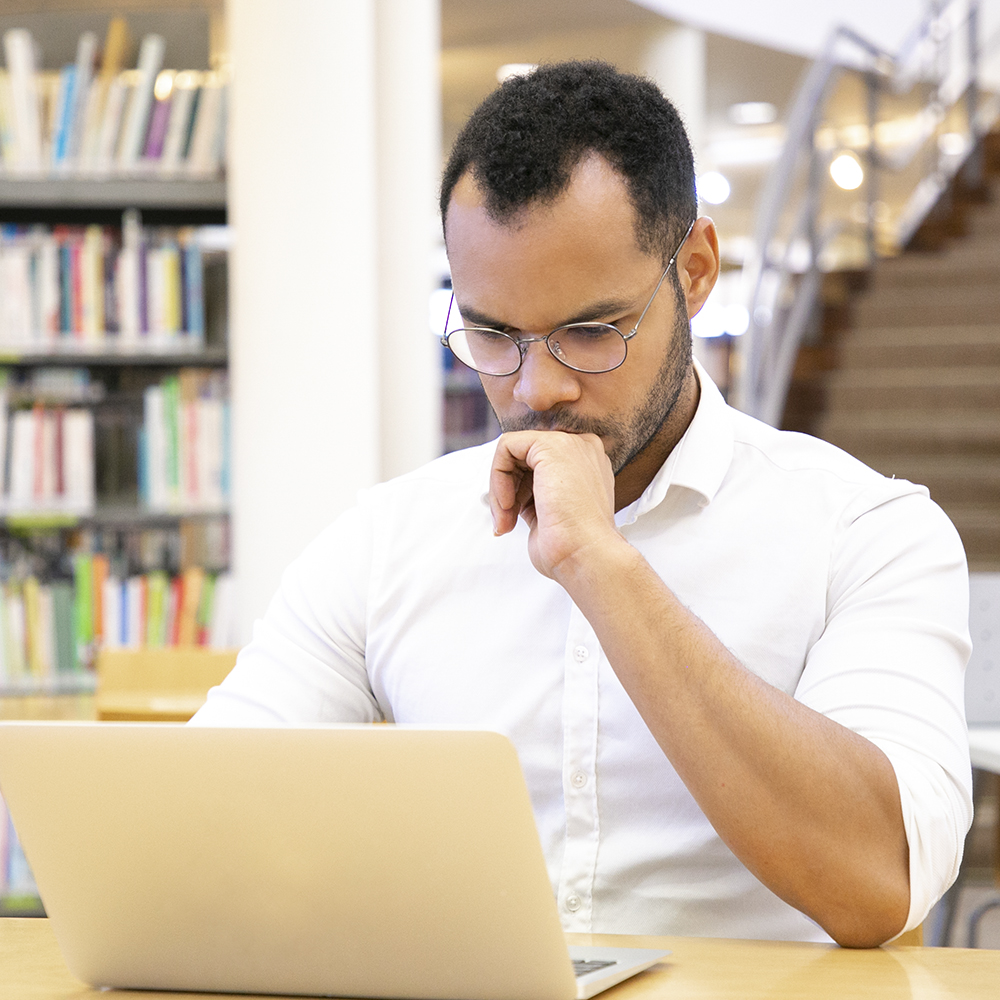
[{"x1": 785, "y1": 153, "x2": 1000, "y2": 571}]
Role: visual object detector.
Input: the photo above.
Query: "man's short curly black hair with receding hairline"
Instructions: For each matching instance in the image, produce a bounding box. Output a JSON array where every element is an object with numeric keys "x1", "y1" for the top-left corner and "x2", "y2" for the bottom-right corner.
[{"x1": 441, "y1": 61, "x2": 698, "y2": 260}]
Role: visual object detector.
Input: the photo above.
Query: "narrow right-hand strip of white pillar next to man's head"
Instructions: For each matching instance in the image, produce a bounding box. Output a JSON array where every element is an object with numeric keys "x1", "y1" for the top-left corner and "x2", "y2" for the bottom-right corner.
[{"x1": 376, "y1": 0, "x2": 442, "y2": 479}]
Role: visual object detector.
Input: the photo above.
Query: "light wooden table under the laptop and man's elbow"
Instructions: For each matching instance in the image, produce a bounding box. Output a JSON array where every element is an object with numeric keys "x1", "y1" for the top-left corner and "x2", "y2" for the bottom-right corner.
[{"x1": 0, "y1": 918, "x2": 1000, "y2": 1000}]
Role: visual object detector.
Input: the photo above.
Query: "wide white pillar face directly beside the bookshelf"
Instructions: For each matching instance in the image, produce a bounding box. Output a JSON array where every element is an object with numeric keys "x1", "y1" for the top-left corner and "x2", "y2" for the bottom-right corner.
[{"x1": 228, "y1": 0, "x2": 379, "y2": 643}]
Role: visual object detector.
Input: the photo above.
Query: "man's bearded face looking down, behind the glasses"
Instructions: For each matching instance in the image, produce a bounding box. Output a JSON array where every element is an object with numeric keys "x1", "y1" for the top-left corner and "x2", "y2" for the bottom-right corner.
[{"x1": 447, "y1": 155, "x2": 714, "y2": 474}]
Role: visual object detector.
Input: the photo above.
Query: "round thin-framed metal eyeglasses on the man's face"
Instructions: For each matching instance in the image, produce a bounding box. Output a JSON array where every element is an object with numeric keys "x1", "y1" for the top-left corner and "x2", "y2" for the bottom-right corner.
[{"x1": 441, "y1": 222, "x2": 694, "y2": 375}]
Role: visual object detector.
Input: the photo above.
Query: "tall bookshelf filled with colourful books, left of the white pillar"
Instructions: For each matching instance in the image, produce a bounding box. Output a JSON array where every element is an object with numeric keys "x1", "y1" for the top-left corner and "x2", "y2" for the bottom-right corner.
[{"x1": 0, "y1": 0, "x2": 231, "y2": 913}]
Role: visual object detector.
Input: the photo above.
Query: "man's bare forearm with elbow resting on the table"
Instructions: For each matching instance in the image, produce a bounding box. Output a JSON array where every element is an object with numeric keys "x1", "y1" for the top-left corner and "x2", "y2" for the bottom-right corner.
[{"x1": 553, "y1": 536, "x2": 909, "y2": 946}]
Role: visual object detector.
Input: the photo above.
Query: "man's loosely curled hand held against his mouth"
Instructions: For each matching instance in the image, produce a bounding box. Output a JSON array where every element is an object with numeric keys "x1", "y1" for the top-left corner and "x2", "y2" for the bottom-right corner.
[{"x1": 490, "y1": 430, "x2": 623, "y2": 579}]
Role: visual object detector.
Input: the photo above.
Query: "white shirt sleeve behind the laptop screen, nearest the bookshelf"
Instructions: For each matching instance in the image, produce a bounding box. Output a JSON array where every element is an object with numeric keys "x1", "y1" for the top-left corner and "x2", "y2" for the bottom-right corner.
[{"x1": 190, "y1": 500, "x2": 381, "y2": 726}]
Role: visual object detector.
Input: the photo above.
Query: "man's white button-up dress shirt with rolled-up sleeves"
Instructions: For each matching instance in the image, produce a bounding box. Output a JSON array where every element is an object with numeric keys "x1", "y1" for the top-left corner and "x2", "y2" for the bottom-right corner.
[{"x1": 194, "y1": 368, "x2": 972, "y2": 940}]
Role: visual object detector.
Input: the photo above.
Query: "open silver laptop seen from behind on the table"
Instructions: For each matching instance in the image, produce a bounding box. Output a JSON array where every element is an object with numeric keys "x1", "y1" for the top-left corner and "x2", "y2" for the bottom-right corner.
[{"x1": 0, "y1": 722, "x2": 669, "y2": 1000}]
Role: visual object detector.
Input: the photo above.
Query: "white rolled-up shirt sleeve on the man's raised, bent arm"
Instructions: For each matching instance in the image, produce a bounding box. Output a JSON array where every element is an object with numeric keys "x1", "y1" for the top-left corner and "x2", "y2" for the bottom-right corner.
[{"x1": 795, "y1": 491, "x2": 972, "y2": 933}]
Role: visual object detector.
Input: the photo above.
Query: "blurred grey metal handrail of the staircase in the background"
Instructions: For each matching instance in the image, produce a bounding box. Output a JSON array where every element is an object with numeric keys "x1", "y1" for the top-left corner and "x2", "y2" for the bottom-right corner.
[{"x1": 731, "y1": 0, "x2": 992, "y2": 426}]
